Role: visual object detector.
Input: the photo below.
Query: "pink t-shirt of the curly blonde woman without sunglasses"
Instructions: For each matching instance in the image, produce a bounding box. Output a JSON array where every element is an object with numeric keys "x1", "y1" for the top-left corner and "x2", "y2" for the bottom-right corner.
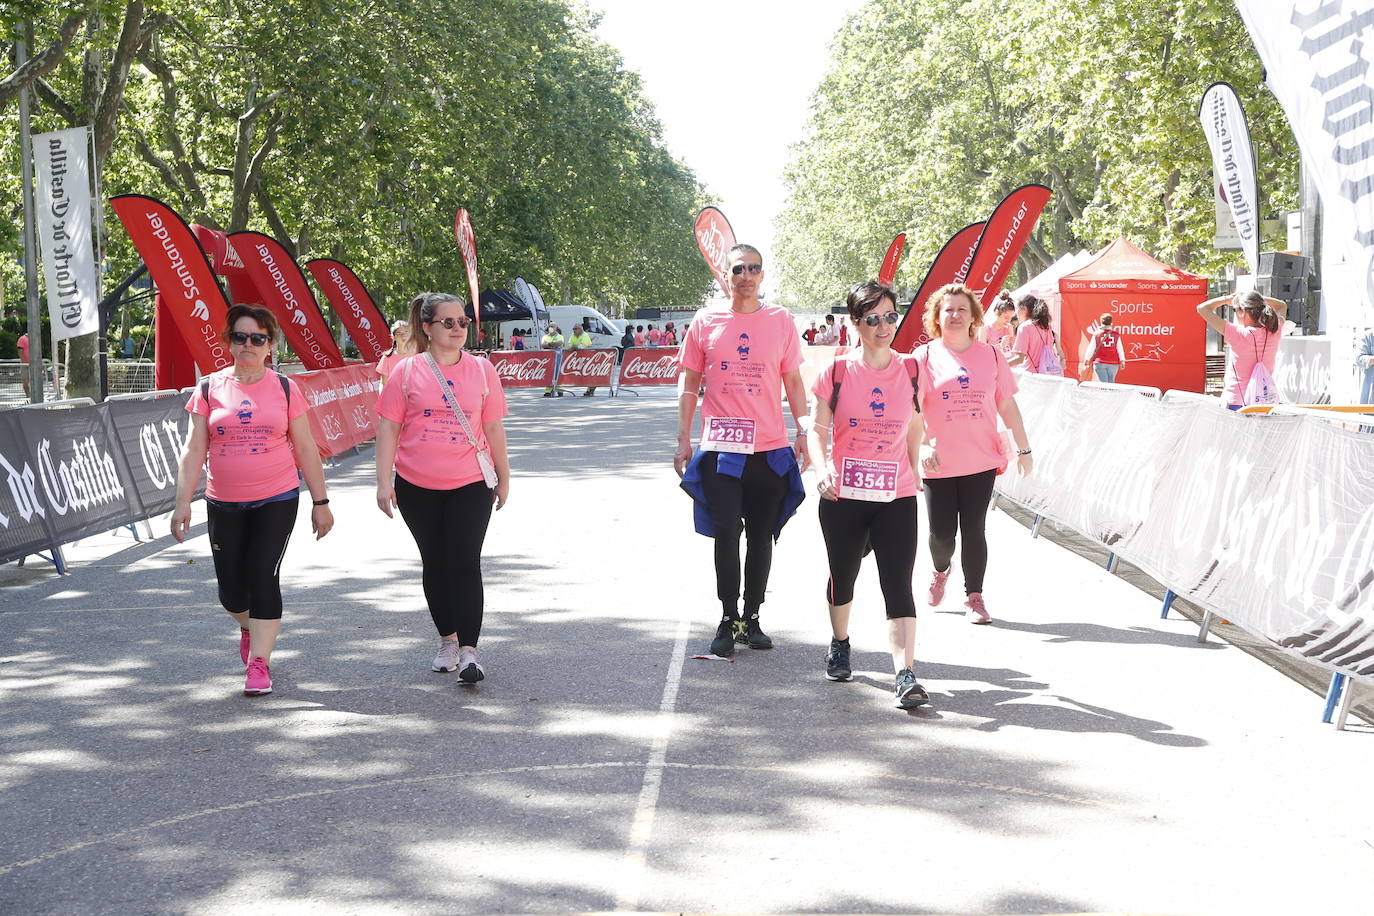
[{"x1": 912, "y1": 341, "x2": 1017, "y2": 478}]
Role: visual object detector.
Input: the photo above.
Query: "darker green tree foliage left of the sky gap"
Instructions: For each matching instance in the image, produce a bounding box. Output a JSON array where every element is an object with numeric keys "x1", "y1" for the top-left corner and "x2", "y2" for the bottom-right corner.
[{"x1": 8, "y1": 0, "x2": 710, "y2": 395}]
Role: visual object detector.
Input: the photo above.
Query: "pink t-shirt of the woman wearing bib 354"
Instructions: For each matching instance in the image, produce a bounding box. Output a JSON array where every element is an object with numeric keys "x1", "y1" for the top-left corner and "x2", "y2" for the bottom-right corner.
[{"x1": 811, "y1": 350, "x2": 916, "y2": 500}]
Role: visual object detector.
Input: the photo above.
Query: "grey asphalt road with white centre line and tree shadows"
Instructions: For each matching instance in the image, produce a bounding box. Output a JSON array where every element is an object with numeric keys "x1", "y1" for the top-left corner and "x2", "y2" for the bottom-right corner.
[{"x1": 0, "y1": 393, "x2": 1374, "y2": 915}]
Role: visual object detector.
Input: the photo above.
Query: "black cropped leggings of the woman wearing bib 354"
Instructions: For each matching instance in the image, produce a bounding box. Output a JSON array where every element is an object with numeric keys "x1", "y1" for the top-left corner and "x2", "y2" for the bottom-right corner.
[{"x1": 820, "y1": 496, "x2": 916, "y2": 621}]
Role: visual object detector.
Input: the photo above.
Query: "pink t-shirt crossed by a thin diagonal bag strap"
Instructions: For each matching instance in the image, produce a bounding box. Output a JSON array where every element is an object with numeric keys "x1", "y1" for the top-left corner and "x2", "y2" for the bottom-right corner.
[{"x1": 376, "y1": 353, "x2": 508, "y2": 490}]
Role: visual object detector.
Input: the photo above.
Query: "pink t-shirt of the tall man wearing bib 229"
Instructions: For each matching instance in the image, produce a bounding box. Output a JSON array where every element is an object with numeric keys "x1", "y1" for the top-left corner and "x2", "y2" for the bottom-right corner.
[{"x1": 677, "y1": 305, "x2": 801, "y2": 452}]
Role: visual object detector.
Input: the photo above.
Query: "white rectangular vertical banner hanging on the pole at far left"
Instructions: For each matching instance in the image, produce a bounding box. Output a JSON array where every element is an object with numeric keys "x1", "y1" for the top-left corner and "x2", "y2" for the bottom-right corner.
[{"x1": 33, "y1": 128, "x2": 100, "y2": 343}]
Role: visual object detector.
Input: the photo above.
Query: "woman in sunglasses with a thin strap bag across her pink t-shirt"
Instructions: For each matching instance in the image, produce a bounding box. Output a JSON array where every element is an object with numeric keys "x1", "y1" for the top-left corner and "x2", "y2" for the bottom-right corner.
[{"x1": 376, "y1": 293, "x2": 511, "y2": 684}]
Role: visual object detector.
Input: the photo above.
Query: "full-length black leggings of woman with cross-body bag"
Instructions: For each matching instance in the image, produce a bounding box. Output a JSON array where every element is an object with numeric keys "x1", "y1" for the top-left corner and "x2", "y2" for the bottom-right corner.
[{"x1": 396, "y1": 474, "x2": 492, "y2": 645}]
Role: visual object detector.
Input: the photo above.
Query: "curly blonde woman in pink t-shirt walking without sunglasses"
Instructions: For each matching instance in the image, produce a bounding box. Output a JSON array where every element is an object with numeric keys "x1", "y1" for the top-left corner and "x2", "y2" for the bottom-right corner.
[{"x1": 914, "y1": 283, "x2": 1032, "y2": 623}]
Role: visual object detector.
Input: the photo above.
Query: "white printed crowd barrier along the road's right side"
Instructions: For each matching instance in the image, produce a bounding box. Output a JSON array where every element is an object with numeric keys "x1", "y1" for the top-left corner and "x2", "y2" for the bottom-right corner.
[{"x1": 998, "y1": 375, "x2": 1374, "y2": 683}]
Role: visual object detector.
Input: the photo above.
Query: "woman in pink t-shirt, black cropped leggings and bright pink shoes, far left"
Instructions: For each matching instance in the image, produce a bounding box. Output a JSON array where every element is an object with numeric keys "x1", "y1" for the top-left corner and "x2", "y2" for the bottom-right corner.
[{"x1": 172, "y1": 305, "x2": 334, "y2": 695}]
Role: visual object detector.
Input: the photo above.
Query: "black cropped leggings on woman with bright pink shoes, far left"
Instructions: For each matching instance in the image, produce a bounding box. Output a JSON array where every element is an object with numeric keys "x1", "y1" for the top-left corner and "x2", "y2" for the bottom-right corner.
[{"x1": 205, "y1": 496, "x2": 301, "y2": 621}]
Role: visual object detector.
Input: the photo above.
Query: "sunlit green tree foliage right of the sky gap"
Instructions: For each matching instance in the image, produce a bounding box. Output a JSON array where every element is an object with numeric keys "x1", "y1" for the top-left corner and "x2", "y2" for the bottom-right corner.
[{"x1": 776, "y1": 0, "x2": 1297, "y2": 308}]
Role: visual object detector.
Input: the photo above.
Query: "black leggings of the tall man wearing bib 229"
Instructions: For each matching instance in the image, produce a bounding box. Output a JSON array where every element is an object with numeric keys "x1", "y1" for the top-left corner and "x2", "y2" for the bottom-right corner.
[{"x1": 701, "y1": 452, "x2": 787, "y2": 617}]
